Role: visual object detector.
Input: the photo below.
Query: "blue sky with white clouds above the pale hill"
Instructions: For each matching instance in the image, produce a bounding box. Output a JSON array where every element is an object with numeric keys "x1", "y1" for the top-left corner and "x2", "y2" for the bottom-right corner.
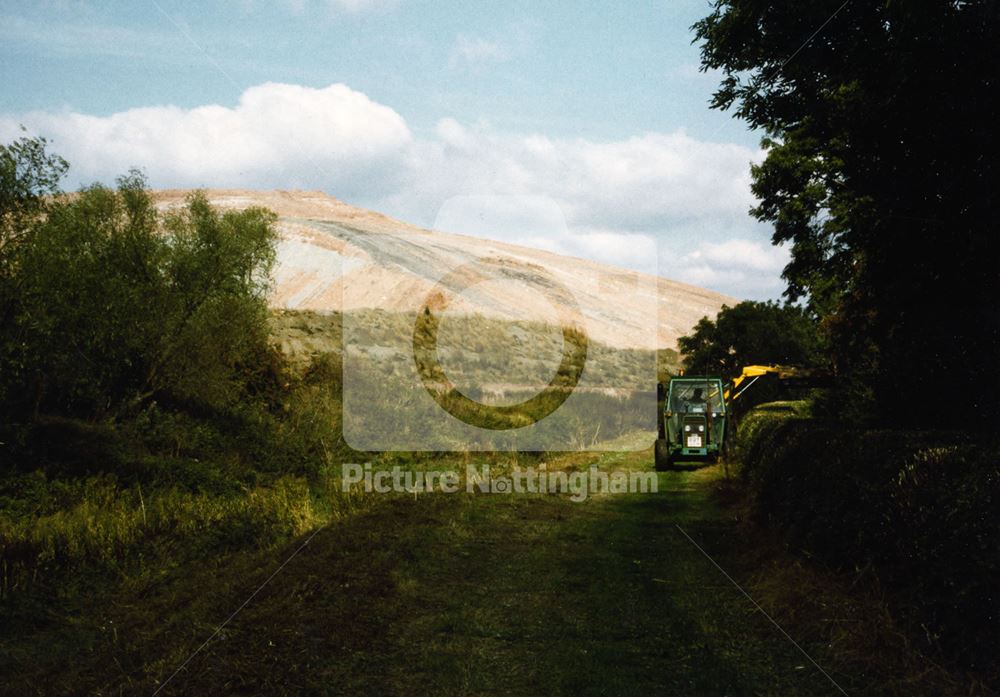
[{"x1": 0, "y1": 0, "x2": 788, "y2": 299}]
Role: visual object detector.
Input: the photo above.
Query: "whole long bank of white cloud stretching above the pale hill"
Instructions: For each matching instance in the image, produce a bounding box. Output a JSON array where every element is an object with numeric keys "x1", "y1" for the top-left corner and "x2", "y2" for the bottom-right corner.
[{"x1": 0, "y1": 83, "x2": 788, "y2": 298}]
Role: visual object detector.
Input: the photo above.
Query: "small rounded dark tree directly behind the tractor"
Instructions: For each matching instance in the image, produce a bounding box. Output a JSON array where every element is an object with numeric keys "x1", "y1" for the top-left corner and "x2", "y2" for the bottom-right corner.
[{"x1": 677, "y1": 300, "x2": 820, "y2": 379}]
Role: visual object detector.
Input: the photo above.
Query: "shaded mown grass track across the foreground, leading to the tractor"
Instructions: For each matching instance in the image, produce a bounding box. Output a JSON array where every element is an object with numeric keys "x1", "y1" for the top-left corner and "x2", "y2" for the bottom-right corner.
[{"x1": 0, "y1": 452, "x2": 988, "y2": 696}]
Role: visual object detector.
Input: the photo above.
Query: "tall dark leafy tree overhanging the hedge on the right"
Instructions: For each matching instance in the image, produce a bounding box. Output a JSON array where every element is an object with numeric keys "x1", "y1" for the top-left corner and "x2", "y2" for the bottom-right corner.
[{"x1": 693, "y1": 0, "x2": 1000, "y2": 428}]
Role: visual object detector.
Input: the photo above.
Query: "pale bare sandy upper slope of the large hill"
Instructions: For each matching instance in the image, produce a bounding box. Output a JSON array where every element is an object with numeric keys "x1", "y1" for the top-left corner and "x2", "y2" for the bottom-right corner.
[{"x1": 154, "y1": 190, "x2": 737, "y2": 348}]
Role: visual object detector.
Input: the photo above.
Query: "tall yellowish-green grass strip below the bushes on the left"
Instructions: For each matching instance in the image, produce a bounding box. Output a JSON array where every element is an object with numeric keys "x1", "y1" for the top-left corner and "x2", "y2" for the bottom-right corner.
[{"x1": 0, "y1": 473, "x2": 330, "y2": 597}]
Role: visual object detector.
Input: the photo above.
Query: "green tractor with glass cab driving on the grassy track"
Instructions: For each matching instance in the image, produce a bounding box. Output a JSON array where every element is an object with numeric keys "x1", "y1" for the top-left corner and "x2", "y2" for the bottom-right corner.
[{"x1": 654, "y1": 375, "x2": 727, "y2": 469}]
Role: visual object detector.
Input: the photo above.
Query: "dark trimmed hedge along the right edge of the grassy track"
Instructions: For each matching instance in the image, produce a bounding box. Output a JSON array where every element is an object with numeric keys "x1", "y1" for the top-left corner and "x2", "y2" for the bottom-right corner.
[{"x1": 737, "y1": 406, "x2": 1000, "y2": 674}]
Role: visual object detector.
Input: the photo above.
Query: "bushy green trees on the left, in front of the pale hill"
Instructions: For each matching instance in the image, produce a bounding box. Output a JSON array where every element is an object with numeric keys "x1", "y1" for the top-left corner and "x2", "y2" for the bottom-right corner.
[{"x1": 0, "y1": 139, "x2": 276, "y2": 420}]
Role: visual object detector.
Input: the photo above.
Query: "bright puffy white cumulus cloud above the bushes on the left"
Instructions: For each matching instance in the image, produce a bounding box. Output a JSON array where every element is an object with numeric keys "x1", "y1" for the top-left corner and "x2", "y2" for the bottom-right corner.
[{"x1": 0, "y1": 83, "x2": 411, "y2": 194}]
